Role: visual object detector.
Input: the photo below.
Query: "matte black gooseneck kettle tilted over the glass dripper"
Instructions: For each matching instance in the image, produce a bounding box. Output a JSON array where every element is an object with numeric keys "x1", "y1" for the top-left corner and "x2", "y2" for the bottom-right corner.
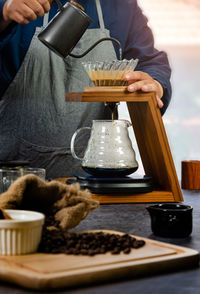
[{"x1": 38, "y1": 0, "x2": 122, "y2": 60}]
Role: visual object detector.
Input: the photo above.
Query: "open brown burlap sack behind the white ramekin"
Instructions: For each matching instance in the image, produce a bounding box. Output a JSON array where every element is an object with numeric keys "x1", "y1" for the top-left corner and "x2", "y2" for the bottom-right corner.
[{"x1": 0, "y1": 174, "x2": 99, "y2": 230}]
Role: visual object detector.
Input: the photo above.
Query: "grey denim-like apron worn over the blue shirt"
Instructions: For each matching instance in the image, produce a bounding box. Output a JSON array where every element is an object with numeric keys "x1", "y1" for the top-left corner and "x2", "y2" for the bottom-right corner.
[{"x1": 0, "y1": 0, "x2": 116, "y2": 178}]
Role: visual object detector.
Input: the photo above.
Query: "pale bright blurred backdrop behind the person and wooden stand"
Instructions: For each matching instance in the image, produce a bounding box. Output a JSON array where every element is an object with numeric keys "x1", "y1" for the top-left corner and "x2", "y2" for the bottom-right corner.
[{"x1": 119, "y1": 0, "x2": 200, "y2": 180}]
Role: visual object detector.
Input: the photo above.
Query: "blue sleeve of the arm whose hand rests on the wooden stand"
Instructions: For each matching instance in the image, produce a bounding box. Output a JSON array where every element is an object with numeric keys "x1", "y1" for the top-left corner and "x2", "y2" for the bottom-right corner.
[{"x1": 124, "y1": 1, "x2": 171, "y2": 114}]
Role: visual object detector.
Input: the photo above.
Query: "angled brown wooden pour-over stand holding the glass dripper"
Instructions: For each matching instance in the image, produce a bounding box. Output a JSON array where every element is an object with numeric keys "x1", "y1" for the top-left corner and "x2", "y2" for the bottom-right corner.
[{"x1": 66, "y1": 86, "x2": 183, "y2": 203}]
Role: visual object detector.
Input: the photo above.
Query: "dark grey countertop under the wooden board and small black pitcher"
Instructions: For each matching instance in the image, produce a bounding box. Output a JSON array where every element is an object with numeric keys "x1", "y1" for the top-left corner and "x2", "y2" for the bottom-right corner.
[{"x1": 0, "y1": 191, "x2": 200, "y2": 294}]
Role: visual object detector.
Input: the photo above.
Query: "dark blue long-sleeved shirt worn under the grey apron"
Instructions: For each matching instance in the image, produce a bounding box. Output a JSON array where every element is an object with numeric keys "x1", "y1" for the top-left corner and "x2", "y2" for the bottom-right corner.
[{"x1": 0, "y1": 0, "x2": 171, "y2": 114}]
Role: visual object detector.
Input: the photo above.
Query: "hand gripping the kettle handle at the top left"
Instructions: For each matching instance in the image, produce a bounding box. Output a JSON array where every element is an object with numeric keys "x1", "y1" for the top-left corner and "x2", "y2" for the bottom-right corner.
[{"x1": 3, "y1": 0, "x2": 50, "y2": 24}]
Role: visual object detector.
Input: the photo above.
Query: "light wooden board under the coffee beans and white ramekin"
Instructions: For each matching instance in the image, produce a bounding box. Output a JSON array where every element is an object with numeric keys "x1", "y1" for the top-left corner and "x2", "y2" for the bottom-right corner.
[{"x1": 0, "y1": 230, "x2": 199, "y2": 290}]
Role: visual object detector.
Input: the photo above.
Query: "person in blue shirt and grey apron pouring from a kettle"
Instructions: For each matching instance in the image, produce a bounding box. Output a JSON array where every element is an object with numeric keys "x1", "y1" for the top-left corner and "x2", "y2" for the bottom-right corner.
[{"x1": 0, "y1": 0, "x2": 171, "y2": 177}]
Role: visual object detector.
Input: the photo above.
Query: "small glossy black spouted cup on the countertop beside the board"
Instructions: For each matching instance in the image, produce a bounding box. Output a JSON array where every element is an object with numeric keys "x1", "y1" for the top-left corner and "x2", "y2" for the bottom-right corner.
[{"x1": 146, "y1": 203, "x2": 193, "y2": 238}]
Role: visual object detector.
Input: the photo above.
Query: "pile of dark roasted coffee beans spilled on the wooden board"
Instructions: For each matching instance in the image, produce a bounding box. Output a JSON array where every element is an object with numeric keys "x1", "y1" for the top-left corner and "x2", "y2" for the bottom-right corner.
[{"x1": 39, "y1": 227, "x2": 145, "y2": 256}]
